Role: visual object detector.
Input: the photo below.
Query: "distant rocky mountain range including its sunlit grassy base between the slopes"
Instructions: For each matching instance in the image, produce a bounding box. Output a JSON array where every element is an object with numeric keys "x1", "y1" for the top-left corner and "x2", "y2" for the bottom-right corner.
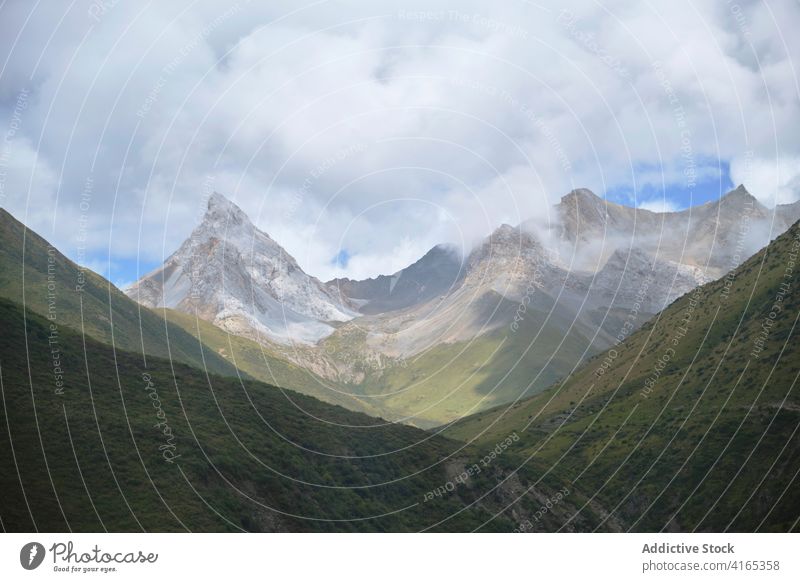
[{"x1": 128, "y1": 186, "x2": 800, "y2": 426}]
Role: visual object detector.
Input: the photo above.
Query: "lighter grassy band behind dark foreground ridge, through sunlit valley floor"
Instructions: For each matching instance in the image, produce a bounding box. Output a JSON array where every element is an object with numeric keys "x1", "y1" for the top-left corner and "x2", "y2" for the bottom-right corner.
[{"x1": 0, "y1": 209, "x2": 600, "y2": 428}]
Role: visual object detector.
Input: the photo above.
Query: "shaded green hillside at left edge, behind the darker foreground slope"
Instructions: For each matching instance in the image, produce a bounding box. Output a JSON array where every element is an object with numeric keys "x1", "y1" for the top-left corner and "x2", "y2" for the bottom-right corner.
[{"x1": 0, "y1": 209, "x2": 236, "y2": 375}]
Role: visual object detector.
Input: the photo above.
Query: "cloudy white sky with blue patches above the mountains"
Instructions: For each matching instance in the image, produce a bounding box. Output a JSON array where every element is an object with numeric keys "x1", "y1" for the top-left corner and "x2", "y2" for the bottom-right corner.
[{"x1": 0, "y1": 0, "x2": 800, "y2": 284}]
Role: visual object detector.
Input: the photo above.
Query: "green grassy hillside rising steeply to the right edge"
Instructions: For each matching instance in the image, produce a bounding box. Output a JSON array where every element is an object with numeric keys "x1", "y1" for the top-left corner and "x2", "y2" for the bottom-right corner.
[{"x1": 447, "y1": 224, "x2": 800, "y2": 531}]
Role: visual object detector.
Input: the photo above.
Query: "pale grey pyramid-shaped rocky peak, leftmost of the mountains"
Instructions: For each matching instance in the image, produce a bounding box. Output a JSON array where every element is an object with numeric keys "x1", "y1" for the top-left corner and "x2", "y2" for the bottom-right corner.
[{"x1": 126, "y1": 193, "x2": 355, "y2": 344}]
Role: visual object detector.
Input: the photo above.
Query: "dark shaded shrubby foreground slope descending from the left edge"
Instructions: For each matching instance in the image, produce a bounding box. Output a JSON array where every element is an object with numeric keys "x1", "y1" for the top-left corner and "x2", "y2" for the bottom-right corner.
[{"x1": 0, "y1": 300, "x2": 599, "y2": 531}]
